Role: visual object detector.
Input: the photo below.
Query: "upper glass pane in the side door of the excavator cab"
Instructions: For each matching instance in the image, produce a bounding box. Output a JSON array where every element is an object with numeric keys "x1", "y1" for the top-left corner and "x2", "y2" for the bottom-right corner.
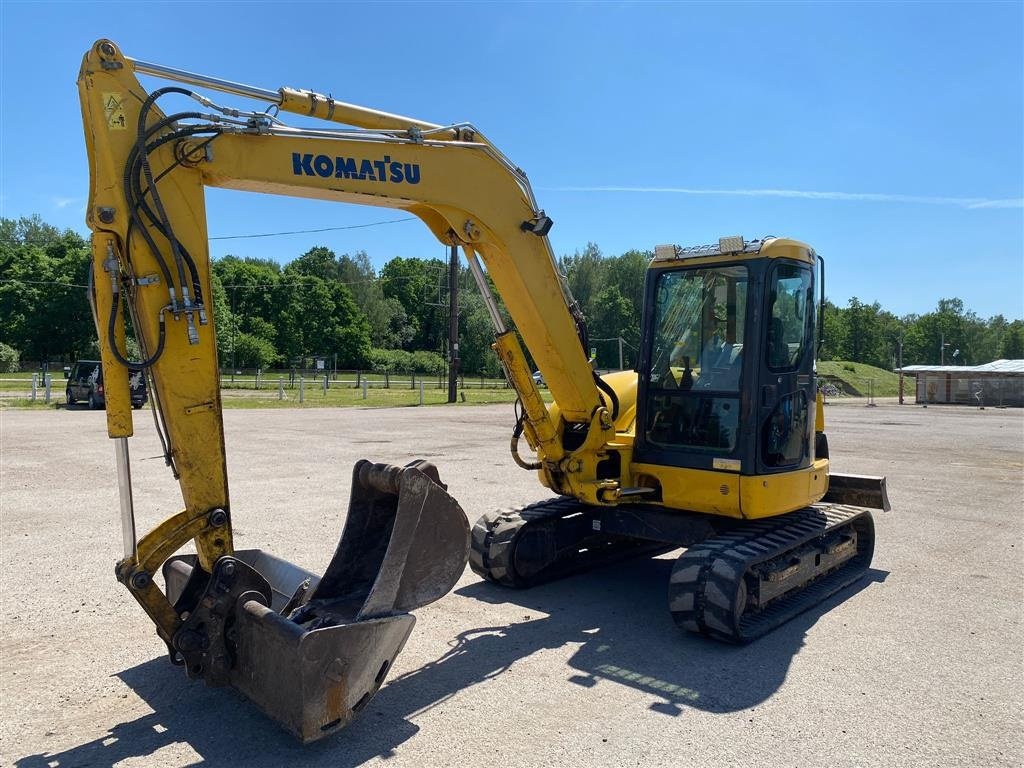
[{"x1": 766, "y1": 263, "x2": 814, "y2": 371}]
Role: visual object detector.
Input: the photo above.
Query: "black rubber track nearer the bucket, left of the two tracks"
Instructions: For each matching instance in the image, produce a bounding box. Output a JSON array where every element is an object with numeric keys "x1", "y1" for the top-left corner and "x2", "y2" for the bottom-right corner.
[{"x1": 469, "y1": 497, "x2": 676, "y2": 589}]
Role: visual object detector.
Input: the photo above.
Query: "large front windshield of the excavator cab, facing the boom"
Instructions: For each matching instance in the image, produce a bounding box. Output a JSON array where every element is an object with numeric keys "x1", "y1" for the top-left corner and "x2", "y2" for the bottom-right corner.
[{"x1": 644, "y1": 265, "x2": 748, "y2": 454}]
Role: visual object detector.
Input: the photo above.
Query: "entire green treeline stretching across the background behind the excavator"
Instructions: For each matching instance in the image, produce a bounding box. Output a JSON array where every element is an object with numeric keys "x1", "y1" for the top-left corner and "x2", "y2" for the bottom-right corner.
[{"x1": 0, "y1": 216, "x2": 1024, "y2": 376}]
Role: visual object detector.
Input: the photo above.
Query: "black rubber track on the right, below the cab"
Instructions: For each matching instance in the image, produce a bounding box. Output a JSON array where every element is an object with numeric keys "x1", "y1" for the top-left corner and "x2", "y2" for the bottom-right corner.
[{"x1": 669, "y1": 505, "x2": 874, "y2": 643}]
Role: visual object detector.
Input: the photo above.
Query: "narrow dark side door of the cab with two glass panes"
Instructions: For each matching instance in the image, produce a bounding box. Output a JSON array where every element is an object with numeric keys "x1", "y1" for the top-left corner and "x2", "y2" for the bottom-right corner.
[{"x1": 757, "y1": 259, "x2": 815, "y2": 474}]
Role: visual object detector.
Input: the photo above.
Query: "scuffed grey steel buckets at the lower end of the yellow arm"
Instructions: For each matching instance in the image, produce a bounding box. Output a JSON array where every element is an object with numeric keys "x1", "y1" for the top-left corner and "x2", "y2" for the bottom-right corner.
[{"x1": 164, "y1": 461, "x2": 469, "y2": 742}]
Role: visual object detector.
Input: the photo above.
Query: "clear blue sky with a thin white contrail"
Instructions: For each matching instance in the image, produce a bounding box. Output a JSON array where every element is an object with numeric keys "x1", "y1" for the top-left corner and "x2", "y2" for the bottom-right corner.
[{"x1": 0, "y1": 0, "x2": 1024, "y2": 317}]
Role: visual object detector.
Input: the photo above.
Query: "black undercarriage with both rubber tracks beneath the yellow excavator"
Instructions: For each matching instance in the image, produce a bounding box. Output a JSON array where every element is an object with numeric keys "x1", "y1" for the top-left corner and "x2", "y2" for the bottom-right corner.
[{"x1": 470, "y1": 498, "x2": 874, "y2": 643}]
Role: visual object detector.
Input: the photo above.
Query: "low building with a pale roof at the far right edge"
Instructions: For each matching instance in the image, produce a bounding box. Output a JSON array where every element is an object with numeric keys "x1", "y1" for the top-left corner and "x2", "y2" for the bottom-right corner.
[{"x1": 903, "y1": 360, "x2": 1024, "y2": 408}]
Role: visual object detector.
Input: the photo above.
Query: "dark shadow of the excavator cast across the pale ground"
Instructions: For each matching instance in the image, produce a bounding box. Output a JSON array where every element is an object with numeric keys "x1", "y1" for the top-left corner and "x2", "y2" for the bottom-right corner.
[{"x1": 15, "y1": 559, "x2": 887, "y2": 768}]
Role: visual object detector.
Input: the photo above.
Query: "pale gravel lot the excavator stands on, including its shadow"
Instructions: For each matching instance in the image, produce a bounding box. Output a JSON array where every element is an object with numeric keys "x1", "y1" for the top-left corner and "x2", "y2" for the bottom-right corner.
[{"x1": 0, "y1": 403, "x2": 1024, "y2": 768}]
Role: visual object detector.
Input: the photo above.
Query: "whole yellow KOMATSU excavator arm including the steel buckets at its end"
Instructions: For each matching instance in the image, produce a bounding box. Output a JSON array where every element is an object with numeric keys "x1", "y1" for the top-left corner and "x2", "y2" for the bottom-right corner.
[{"x1": 78, "y1": 40, "x2": 616, "y2": 740}]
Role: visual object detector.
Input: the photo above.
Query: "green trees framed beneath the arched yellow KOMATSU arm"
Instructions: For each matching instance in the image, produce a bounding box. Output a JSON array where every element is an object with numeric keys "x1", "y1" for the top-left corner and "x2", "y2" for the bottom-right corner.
[{"x1": 213, "y1": 247, "x2": 500, "y2": 376}]
